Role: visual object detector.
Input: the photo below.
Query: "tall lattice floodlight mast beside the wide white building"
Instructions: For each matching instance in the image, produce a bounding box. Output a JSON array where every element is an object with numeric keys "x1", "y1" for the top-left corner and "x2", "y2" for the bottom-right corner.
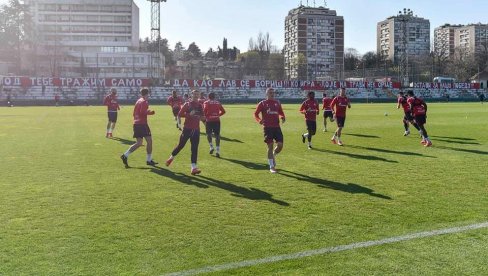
[{"x1": 147, "y1": 0, "x2": 166, "y2": 78}]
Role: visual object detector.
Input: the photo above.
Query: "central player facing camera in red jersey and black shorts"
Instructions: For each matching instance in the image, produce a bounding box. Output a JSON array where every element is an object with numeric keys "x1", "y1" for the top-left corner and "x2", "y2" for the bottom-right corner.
[{"x1": 254, "y1": 88, "x2": 285, "y2": 173}]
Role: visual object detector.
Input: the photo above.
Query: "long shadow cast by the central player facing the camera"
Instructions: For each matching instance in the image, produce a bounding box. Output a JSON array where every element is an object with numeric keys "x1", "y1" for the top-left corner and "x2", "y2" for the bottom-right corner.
[{"x1": 279, "y1": 170, "x2": 392, "y2": 200}]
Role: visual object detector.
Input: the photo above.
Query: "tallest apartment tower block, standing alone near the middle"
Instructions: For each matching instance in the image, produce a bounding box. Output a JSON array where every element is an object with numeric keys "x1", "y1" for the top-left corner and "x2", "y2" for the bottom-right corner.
[{"x1": 284, "y1": 6, "x2": 344, "y2": 80}]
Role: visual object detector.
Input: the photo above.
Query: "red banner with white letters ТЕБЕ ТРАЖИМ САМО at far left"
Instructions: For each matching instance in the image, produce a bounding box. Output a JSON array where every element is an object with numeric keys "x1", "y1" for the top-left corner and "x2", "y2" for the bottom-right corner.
[{"x1": 2, "y1": 77, "x2": 151, "y2": 87}]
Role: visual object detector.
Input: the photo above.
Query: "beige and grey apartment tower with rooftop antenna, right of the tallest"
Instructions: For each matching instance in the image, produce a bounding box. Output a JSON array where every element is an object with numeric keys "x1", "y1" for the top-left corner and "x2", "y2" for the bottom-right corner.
[{"x1": 376, "y1": 14, "x2": 430, "y2": 63}]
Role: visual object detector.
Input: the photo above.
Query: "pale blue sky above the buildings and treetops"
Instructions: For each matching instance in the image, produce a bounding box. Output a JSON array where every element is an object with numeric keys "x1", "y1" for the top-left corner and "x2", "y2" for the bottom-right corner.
[{"x1": 0, "y1": 0, "x2": 488, "y2": 54}]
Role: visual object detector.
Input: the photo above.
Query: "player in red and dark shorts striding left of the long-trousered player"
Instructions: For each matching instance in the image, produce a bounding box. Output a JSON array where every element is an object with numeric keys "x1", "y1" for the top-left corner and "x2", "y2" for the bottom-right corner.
[{"x1": 120, "y1": 88, "x2": 158, "y2": 168}]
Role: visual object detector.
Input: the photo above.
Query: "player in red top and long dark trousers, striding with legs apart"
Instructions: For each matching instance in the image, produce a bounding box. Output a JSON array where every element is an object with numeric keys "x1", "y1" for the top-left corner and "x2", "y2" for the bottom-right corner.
[{"x1": 166, "y1": 90, "x2": 205, "y2": 175}]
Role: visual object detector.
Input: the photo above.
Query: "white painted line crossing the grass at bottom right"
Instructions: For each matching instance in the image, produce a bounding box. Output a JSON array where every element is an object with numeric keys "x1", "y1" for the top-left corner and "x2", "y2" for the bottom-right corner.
[{"x1": 166, "y1": 222, "x2": 488, "y2": 276}]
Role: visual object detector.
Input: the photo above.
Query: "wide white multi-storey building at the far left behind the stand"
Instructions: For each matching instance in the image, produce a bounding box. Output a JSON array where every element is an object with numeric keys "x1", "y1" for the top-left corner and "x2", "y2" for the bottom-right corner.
[{"x1": 24, "y1": 0, "x2": 160, "y2": 77}]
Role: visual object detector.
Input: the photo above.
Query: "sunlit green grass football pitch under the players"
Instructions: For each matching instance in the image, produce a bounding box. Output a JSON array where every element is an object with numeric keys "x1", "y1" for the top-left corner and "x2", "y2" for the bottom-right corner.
[{"x1": 0, "y1": 103, "x2": 488, "y2": 275}]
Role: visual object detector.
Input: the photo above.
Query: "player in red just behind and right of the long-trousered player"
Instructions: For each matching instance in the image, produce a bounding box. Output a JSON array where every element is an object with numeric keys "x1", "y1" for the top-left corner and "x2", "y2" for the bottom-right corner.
[{"x1": 203, "y1": 92, "x2": 225, "y2": 157}]
